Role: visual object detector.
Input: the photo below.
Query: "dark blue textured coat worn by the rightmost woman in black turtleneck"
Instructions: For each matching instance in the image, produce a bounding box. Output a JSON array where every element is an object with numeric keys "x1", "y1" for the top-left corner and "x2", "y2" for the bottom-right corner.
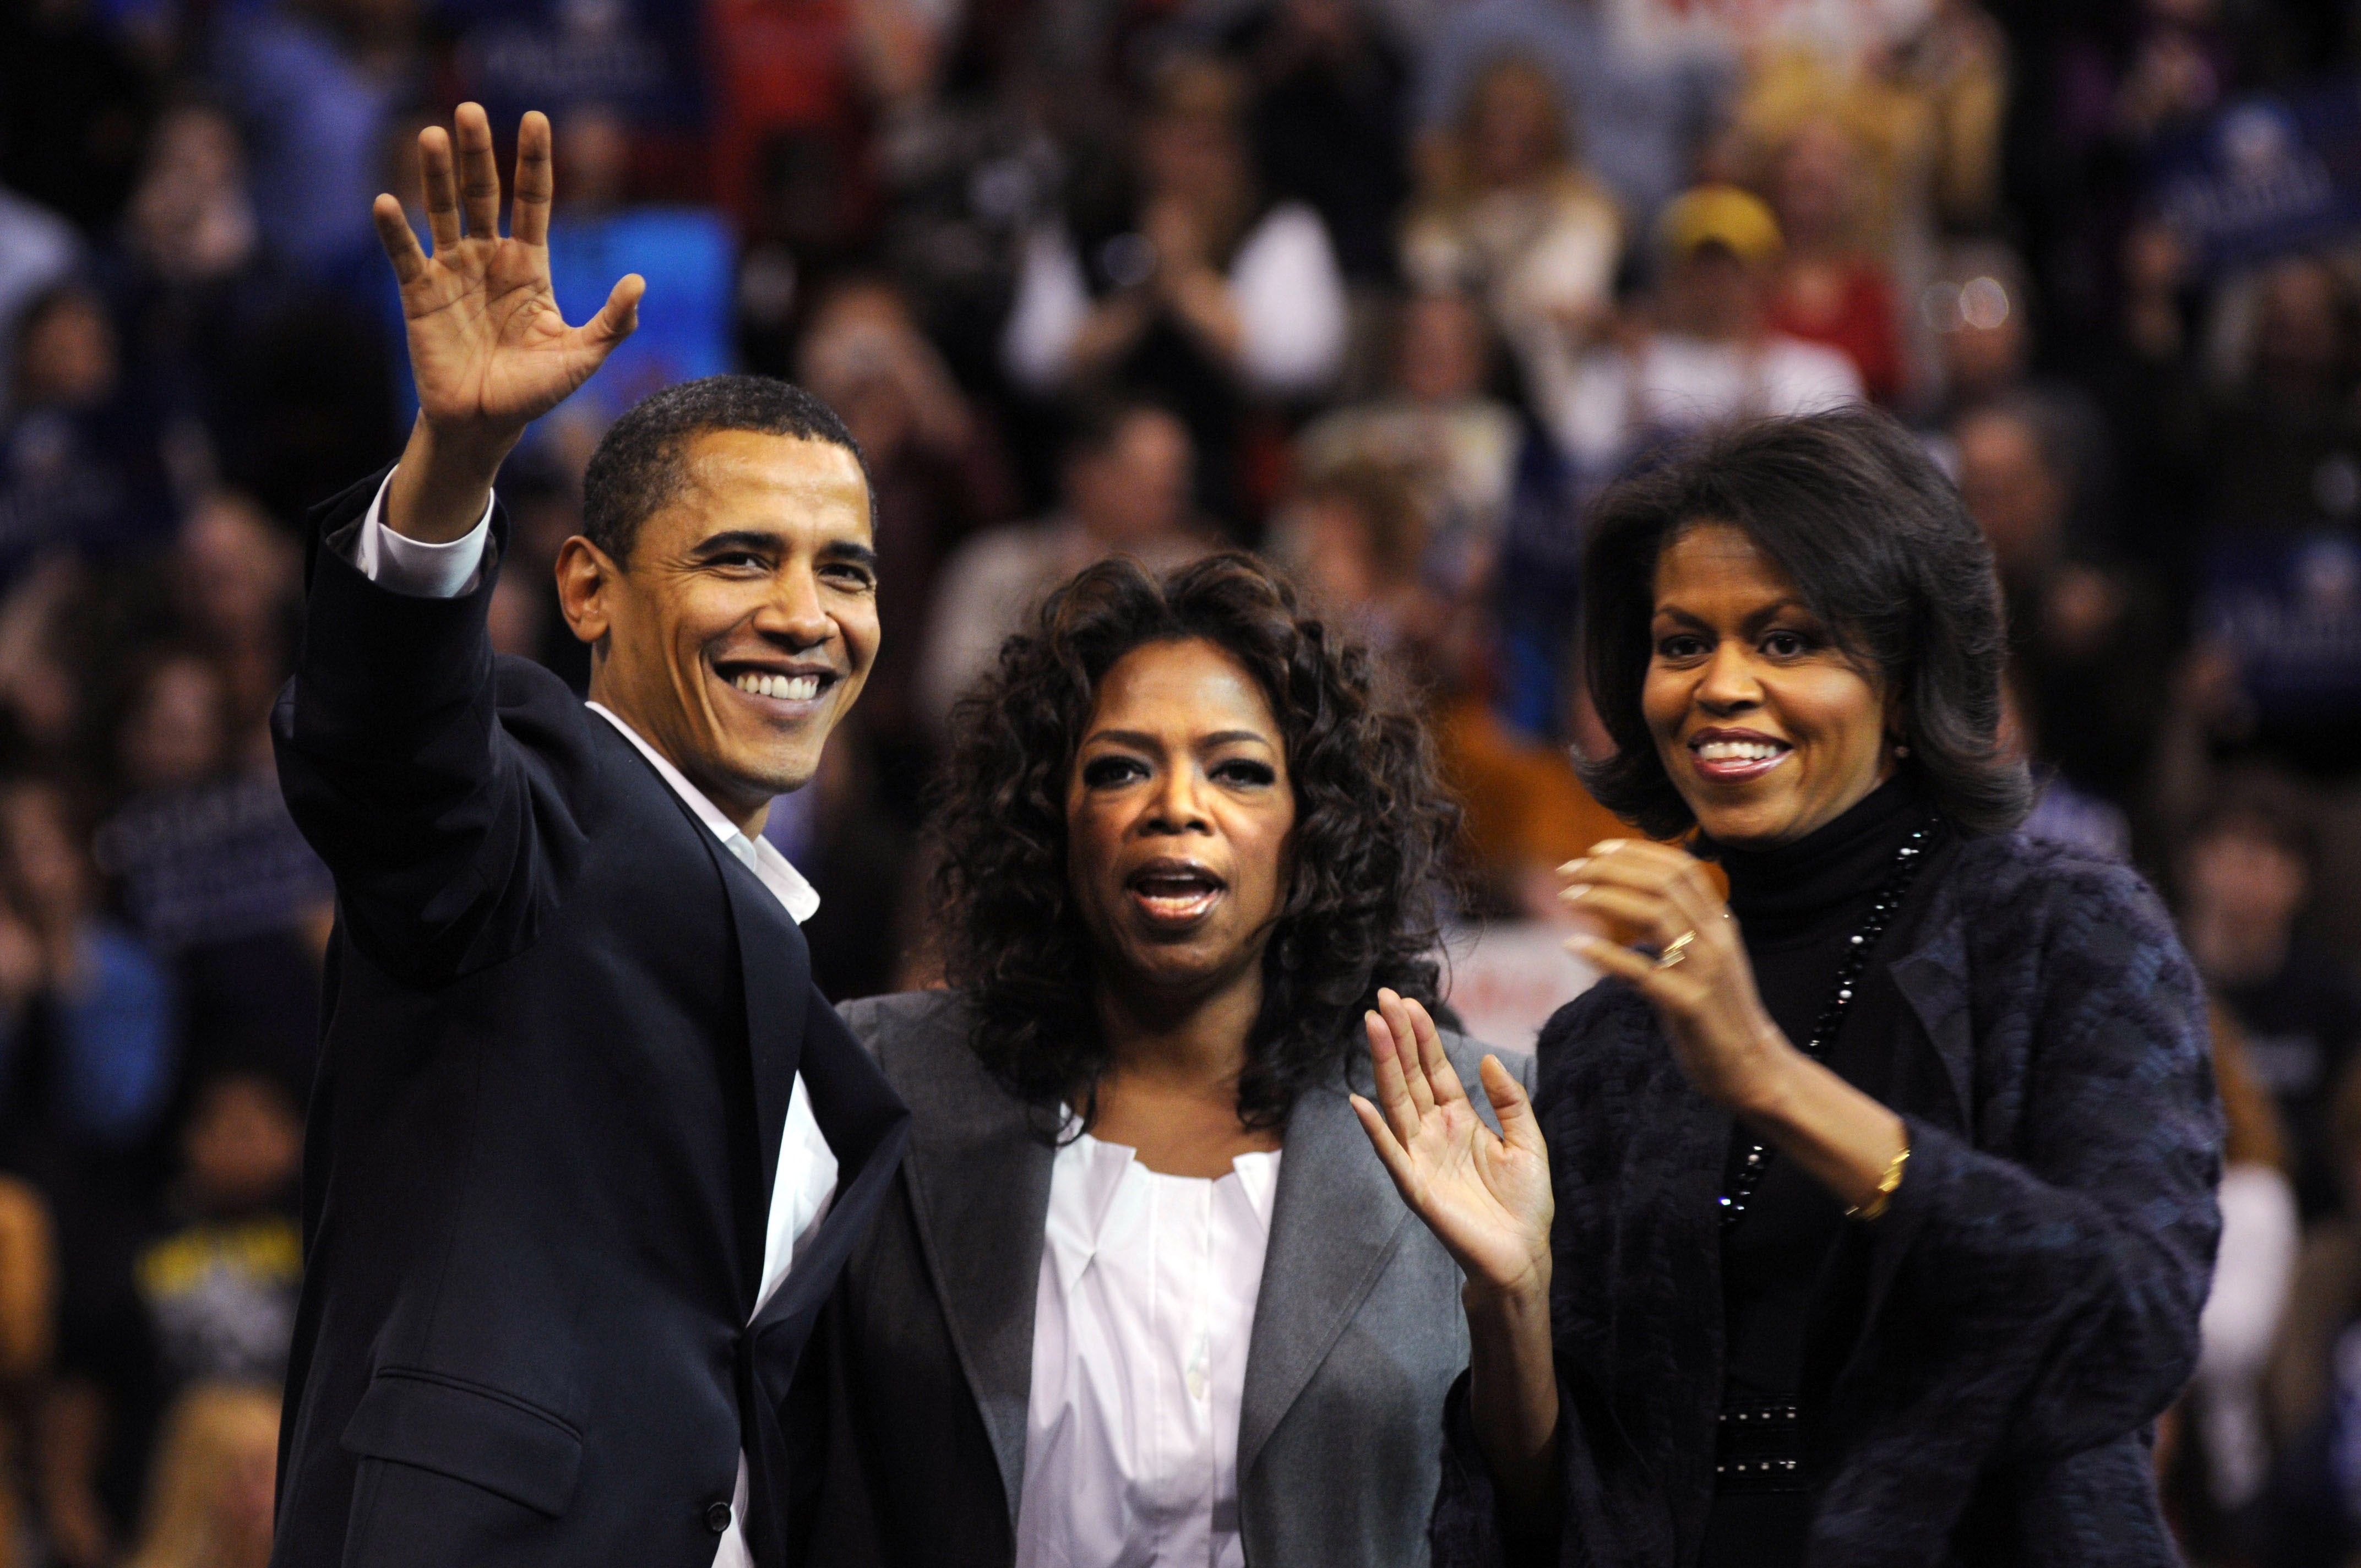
[{"x1": 1433, "y1": 836, "x2": 2222, "y2": 1568}]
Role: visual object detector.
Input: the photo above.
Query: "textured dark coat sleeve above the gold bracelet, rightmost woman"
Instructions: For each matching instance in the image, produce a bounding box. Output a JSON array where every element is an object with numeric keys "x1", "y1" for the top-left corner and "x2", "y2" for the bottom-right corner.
[{"x1": 1872, "y1": 864, "x2": 2222, "y2": 1462}]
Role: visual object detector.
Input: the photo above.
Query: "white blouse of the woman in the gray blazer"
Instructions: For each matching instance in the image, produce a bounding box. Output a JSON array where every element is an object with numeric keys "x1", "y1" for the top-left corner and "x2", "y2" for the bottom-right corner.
[{"x1": 1015, "y1": 1134, "x2": 1280, "y2": 1568}]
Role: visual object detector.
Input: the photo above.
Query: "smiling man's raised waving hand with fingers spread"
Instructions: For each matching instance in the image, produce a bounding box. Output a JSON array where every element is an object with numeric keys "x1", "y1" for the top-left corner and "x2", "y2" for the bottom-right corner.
[{"x1": 371, "y1": 104, "x2": 645, "y2": 439}]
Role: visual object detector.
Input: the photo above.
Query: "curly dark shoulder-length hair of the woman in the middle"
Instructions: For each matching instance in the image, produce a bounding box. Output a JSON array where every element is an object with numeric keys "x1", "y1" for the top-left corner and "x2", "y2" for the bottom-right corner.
[{"x1": 933, "y1": 553, "x2": 1459, "y2": 1126}]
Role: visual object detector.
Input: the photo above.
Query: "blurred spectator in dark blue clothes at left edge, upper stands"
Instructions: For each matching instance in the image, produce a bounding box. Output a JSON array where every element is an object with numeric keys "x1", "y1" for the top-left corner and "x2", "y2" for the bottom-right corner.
[{"x1": 0, "y1": 284, "x2": 172, "y2": 581}]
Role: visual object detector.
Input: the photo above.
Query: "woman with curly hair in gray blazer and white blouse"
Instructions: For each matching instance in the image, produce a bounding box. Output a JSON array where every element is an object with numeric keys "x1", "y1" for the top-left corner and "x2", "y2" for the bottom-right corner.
[{"x1": 798, "y1": 555, "x2": 1530, "y2": 1568}]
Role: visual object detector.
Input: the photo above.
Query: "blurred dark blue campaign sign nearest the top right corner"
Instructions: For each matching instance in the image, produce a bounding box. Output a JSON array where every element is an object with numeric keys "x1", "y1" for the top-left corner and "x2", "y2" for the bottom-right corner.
[{"x1": 2148, "y1": 78, "x2": 2361, "y2": 271}]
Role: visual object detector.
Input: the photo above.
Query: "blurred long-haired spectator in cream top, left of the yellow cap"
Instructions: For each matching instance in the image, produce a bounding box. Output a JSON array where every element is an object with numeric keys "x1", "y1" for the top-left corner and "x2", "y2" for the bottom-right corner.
[{"x1": 1402, "y1": 57, "x2": 1624, "y2": 373}]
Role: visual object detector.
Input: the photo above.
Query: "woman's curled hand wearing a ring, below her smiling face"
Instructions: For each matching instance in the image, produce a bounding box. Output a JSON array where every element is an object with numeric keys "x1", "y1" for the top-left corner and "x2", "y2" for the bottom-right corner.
[{"x1": 1558, "y1": 839, "x2": 1797, "y2": 1112}]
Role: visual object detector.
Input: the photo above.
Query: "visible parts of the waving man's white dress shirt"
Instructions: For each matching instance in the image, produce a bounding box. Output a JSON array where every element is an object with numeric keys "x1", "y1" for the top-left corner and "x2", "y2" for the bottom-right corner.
[{"x1": 354, "y1": 475, "x2": 836, "y2": 1568}]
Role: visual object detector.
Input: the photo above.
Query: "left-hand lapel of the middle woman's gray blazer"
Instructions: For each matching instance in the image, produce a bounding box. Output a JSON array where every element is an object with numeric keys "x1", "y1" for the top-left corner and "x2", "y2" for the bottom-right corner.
[{"x1": 883, "y1": 1006, "x2": 1056, "y2": 1528}]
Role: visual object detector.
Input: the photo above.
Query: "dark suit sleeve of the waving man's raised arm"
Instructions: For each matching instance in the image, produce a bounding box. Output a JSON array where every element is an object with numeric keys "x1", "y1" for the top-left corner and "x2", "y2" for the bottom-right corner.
[{"x1": 271, "y1": 462, "x2": 579, "y2": 985}]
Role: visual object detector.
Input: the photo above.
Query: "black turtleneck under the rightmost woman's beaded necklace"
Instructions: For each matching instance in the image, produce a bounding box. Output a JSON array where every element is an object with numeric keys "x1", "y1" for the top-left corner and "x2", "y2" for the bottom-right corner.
[{"x1": 1700, "y1": 775, "x2": 1957, "y2": 1568}]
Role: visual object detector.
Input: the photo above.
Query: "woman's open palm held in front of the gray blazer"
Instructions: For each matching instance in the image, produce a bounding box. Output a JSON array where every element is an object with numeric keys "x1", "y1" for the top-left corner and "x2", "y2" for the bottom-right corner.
[{"x1": 1353, "y1": 992, "x2": 1556, "y2": 1299}]
